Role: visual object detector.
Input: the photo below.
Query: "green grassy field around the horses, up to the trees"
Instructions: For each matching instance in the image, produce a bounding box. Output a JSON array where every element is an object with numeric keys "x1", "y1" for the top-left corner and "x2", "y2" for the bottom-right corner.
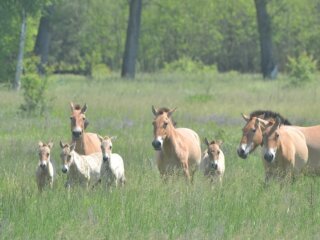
[{"x1": 0, "y1": 73, "x2": 320, "y2": 239}]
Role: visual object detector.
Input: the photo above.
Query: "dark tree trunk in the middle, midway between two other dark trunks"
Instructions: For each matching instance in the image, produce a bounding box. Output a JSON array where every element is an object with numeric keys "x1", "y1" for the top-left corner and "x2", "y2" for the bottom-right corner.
[{"x1": 121, "y1": 0, "x2": 142, "y2": 78}]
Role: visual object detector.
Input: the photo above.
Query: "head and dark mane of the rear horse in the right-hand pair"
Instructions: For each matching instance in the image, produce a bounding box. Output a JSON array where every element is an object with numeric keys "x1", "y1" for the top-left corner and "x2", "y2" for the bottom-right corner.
[{"x1": 237, "y1": 110, "x2": 291, "y2": 159}]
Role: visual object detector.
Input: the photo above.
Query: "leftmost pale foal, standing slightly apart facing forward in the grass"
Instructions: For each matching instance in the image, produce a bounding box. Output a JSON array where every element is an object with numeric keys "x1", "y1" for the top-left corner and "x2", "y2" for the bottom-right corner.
[{"x1": 36, "y1": 141, "x2": 54, "y2": 192}]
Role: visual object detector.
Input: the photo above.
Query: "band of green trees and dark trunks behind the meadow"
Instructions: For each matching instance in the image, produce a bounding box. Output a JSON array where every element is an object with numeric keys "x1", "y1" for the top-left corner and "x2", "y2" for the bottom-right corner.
[{"x1": 0, "y1": 0, "x2": 320, "y2": 87}]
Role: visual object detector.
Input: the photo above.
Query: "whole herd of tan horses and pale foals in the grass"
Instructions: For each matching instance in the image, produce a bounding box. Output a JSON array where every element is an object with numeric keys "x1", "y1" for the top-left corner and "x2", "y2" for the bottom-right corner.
[{"x1": 36, "y1": 103, "x2": 320, "y2": 192}]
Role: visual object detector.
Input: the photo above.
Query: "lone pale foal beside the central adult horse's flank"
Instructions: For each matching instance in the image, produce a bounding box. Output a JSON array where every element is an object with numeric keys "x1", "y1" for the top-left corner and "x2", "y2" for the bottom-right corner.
[{"x1": 200, "y1": 138, "x2": 225, "y2": 182}]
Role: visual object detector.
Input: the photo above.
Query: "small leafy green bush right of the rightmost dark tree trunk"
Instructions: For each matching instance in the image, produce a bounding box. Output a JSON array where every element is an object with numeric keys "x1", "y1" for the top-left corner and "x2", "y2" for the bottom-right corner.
[{"x1": 287, "y1": 52, "x2": 317, "y2": 85}]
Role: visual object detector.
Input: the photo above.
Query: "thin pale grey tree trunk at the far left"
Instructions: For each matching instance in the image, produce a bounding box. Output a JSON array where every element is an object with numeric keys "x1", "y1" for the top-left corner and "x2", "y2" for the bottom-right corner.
[{"x1": 13, "y1": 9, "x2": 27, "y2": 91}]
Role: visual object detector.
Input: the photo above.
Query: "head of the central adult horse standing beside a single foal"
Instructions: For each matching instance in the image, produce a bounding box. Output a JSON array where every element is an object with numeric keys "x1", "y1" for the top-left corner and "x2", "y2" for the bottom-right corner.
[{"x1": 152, "y1": 106, "x2": 176, "y2": 151}]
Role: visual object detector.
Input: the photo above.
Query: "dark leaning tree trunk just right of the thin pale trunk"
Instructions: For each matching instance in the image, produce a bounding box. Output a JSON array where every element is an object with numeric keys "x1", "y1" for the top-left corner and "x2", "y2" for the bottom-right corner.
[{"x1": 33, "y1": 5, "x2": 53, "y2": 74}]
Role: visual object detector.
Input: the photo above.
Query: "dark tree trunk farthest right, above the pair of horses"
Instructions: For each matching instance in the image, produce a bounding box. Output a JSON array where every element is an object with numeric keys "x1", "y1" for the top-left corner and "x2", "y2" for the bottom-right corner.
[{"x1": 254, "y1": 0, "x2": 277, "y2": 79}]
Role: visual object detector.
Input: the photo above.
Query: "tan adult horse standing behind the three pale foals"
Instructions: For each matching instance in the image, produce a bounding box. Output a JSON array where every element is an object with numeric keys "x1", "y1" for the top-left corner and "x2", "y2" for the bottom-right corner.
[{"x1": 70, "y1": 102, "x2": 101, "y2": 155}]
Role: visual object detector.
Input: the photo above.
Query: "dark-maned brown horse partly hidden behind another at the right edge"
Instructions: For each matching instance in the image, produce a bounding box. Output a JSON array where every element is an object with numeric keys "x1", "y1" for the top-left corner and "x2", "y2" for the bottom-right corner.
[{"x1": 238, "y1": 110, "x2": 320, "y2": 175}]
